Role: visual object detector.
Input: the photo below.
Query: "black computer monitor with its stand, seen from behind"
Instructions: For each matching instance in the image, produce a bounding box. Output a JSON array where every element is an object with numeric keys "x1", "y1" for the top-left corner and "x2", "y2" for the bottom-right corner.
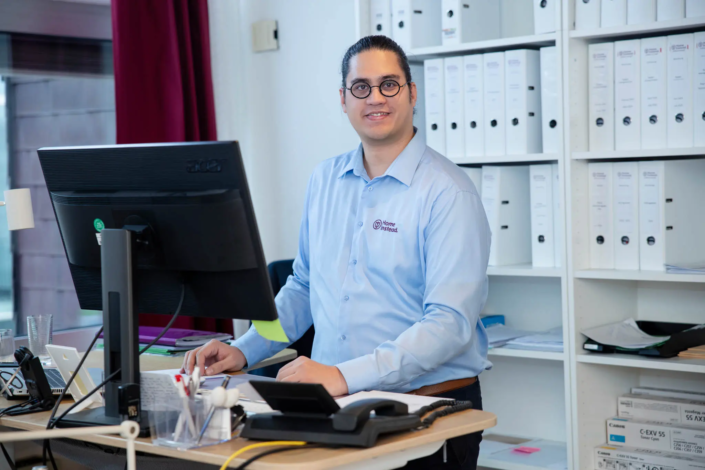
[{"x1": 38, "y1": 142, "x2": 277, "y2": 434}]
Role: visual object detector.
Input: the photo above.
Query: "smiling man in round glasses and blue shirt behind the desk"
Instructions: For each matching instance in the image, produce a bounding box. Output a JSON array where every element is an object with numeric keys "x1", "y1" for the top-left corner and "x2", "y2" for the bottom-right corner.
[{"x1": 184, "y1": 36, "x2": 491, "y2": 468}]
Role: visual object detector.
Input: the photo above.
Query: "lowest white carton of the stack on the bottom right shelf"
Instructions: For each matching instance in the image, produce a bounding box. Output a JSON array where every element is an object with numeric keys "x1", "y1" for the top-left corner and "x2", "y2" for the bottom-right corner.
[{"x1": 594, "y1": 444, "x2": 705, "y2": 470}]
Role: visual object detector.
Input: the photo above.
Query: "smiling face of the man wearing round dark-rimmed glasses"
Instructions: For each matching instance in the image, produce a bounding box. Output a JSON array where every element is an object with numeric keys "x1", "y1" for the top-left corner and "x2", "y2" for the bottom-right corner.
[{"x1": 340, "y1": 49, "x2": 416, "y2": 142}]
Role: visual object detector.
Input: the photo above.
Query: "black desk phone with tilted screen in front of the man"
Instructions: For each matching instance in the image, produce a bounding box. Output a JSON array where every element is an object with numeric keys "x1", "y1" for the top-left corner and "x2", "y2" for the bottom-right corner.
[{"x1": 240, "y1": 380, "x2": 422, "y2": 447}]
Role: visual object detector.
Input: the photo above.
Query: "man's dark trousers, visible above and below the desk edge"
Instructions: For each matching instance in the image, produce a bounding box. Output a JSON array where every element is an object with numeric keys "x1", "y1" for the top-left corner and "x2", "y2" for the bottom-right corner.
[{"x1": 403, "y1": 379, "x2": 482, "y2": 470}]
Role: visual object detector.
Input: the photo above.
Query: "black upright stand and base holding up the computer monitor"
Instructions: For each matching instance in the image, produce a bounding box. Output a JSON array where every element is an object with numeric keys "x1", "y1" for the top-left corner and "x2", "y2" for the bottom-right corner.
[{"x1": 56, "y1": 225, "x2": 149, "y2": 437}]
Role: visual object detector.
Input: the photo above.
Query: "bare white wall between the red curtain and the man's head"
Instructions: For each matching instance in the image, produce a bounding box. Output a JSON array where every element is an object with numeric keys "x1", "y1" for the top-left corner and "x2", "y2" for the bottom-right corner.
[{"x1": 209, "y1": 0, "x2": 359, "y2": 262}]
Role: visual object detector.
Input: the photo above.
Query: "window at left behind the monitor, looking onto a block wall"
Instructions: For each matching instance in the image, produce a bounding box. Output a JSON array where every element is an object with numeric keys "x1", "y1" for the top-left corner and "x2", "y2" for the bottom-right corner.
[{"x1": 0, "y1": 35, "x2": 115, "y2": 335}]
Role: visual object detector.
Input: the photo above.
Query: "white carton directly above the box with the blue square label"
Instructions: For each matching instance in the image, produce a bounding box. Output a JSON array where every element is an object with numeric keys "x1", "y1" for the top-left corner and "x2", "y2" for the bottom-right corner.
[{"x1": 617, "y1": 394, "x2": 705, "y2": 428}]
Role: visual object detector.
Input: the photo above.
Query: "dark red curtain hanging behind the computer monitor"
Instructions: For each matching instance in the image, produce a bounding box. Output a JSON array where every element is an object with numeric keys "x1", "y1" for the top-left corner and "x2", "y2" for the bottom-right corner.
[{"x1": 111, "y1": 0, "x2": 232, "y2": 333}]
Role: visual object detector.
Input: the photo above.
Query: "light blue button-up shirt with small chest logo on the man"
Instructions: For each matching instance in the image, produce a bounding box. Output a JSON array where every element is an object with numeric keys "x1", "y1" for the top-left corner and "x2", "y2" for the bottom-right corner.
[{"x1": 234, "y1": 129, "x2": 492, "y2": 393}]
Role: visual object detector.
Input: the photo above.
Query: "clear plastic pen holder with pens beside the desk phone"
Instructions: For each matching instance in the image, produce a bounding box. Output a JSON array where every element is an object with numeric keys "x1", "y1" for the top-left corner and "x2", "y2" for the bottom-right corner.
[{"x1": 150, "y1": 395, "x2": 232, "y2": 449}]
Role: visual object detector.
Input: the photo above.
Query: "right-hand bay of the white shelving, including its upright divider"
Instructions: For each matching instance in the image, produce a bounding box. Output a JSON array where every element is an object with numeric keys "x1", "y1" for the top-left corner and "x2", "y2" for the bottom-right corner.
[{"x1": 561, "y1": 0, "x2": 705, "y2": 470}]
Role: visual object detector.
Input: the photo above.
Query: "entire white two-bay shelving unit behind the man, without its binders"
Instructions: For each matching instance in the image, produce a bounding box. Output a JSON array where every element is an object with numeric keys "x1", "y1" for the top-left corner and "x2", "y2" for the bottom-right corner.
[{"x1": 357, "y1": 0, "x2": 705, "y2": 470}]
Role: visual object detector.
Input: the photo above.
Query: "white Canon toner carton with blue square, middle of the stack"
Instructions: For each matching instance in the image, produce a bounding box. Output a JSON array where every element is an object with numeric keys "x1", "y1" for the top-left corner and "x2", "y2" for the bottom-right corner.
[{"x1": 607, "y1": 418, "x2": 705, "y2": 457}]
